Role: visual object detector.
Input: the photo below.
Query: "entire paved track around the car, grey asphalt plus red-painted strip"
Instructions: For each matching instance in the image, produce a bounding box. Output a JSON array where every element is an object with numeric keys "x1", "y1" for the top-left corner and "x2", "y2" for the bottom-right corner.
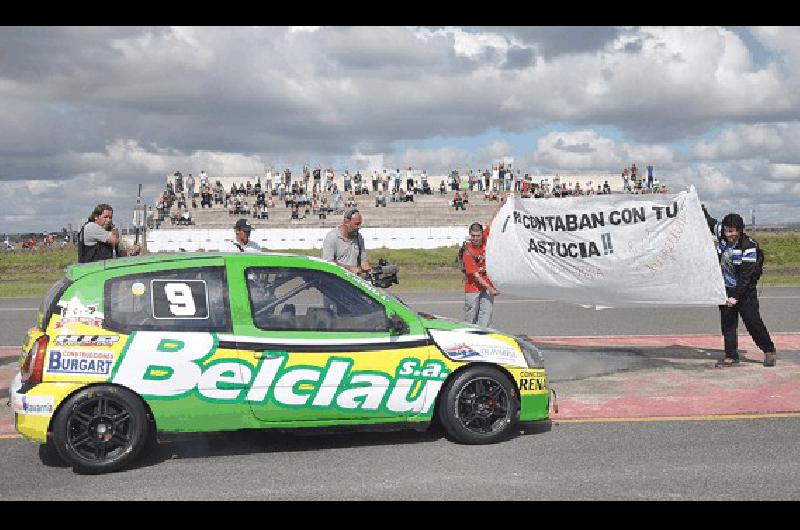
[{"x1": 0, "y1": 287, "x2": 800, "y2": 500}]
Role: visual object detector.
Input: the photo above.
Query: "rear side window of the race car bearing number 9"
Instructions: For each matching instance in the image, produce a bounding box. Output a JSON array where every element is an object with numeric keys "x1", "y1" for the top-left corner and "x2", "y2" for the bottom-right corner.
[{"x1": 104, "y1": 267, "x2": 232, "y2": 332}]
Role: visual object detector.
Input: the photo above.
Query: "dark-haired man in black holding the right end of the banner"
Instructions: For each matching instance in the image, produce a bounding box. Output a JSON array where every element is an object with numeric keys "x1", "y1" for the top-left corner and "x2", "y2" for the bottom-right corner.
[{"x1": 703, "y1": 205, "x2": 777, "y2": 367}]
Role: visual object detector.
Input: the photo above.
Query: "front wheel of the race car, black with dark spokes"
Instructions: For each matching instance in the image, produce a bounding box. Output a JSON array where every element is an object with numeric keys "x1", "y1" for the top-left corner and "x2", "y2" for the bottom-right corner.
[{"x1": 438, "y1": 366, "x2": 519, "y2": 445}]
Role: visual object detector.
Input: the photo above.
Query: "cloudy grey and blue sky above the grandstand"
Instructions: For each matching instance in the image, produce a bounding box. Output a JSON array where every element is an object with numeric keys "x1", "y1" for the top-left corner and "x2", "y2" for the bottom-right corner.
[{"x1": 0, "y1": 26, "x2": 800, "y2": 233}]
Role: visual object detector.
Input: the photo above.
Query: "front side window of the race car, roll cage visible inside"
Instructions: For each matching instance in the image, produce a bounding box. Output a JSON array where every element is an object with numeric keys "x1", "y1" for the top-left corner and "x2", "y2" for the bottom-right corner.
[{"x1": 245, "y1": 267, "x2": 389, "y2": 332}]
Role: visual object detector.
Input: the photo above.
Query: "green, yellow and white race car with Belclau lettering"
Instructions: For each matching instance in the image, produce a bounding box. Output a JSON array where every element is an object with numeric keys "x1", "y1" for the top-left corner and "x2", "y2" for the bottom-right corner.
[{"x1": 9, "y1": 253, "x2": 550, "y2": 473}]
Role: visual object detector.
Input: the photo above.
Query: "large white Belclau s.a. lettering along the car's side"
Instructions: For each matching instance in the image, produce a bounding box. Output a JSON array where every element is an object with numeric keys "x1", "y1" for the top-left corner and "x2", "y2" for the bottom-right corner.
[{"x1": 113, "y1": 332, "x2": 450, "y2": 414}]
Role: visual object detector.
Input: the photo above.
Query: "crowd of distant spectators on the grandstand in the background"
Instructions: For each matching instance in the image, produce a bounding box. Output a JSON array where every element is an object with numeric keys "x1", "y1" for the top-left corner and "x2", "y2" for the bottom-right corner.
[{"x1": 148, "y1": 162, "x2": 667, "y2": 228}]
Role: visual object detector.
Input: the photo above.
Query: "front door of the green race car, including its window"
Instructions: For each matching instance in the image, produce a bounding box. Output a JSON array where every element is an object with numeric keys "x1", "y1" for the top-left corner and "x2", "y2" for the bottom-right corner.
[{"x1": 229, "y1": 258, "x2": 438, "y2": 425}]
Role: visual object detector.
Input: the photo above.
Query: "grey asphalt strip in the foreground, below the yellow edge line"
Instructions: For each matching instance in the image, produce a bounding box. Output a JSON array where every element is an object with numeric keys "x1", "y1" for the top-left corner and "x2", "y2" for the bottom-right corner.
[{"x1": 0, "y1": 418, "x2": 800, "y2": 498}]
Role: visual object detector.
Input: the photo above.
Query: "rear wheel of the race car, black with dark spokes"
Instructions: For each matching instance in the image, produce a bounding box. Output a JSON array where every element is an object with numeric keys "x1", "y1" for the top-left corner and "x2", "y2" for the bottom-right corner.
[{"x1": 53, "y1": 386, "x2": 151, "y2": 474}]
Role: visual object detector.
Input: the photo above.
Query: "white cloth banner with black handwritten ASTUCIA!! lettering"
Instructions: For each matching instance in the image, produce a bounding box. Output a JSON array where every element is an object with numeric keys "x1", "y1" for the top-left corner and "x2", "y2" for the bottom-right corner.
[{"x1": 486, "y1": 188, "x2": 726, "y2": 309}]
